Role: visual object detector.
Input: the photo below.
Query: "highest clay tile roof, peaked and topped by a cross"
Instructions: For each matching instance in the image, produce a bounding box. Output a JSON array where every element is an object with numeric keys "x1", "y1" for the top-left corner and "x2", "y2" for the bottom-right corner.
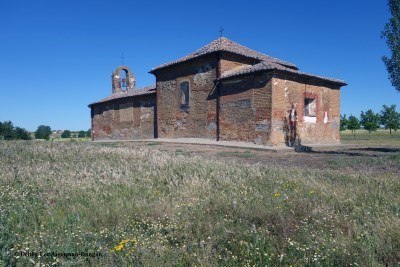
[{"x1": 150, "y1": 37, "x2": 297, "y2": 73}]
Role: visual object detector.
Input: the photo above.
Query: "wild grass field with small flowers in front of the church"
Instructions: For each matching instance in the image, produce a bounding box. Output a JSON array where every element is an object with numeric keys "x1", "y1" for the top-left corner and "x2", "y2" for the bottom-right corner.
[{"x1": 0, "y1": 136, "x2": 400, "y2": 266}]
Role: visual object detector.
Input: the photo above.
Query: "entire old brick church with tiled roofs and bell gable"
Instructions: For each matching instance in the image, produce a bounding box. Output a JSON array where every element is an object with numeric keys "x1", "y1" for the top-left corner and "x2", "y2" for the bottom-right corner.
[{"x1": 89, "y1": 37, "x2": 346, "y2": 145}]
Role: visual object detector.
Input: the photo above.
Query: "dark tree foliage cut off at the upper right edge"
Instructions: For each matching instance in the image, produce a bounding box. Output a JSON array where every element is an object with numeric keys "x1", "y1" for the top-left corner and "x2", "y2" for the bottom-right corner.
[{"x1": 382, "y1": 0, "x2": 400, "y2": 92}]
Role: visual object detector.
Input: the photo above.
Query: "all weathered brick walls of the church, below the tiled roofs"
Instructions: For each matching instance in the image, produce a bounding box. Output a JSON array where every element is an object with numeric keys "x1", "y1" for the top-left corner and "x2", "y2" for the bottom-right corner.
[{"x1": 92, "y1": 56, "x2": 340, "y2": 145}]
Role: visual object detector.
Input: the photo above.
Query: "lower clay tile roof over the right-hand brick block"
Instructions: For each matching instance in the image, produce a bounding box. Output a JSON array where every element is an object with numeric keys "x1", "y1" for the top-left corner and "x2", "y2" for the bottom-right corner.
[{"x1": 220, "y1": 61, "x2": 347, "y2": 86}]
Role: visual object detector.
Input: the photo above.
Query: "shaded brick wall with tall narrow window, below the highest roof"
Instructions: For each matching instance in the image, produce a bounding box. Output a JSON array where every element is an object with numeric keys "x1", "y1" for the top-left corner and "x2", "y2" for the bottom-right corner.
[{"x1": 155, "y1": 55, "x2": 217, "y2": 139}]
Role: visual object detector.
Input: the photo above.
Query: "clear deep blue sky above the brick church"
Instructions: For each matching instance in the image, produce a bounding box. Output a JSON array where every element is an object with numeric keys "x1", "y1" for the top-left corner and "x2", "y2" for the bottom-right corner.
[{"x1": 0, "y1": 0, "x2": 400, "y2": 131}]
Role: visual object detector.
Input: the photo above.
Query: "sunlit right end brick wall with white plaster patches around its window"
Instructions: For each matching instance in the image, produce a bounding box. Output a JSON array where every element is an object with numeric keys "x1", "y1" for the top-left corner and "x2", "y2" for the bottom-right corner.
[{"x1": 270, "y1": 74, "x2": 340, "y2": 145}]
